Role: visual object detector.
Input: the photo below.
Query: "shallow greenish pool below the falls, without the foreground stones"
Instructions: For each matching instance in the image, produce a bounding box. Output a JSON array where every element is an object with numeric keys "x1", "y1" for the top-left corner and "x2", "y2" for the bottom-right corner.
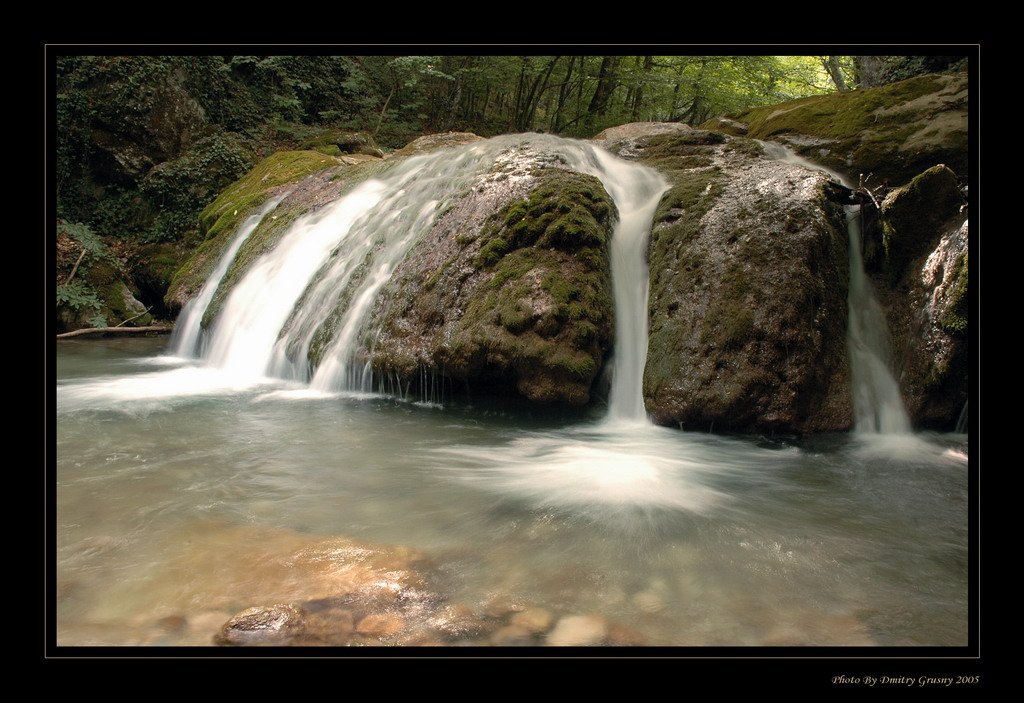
[{"x1": 55, "y1": 340, "x2": 968, "y2": 646}]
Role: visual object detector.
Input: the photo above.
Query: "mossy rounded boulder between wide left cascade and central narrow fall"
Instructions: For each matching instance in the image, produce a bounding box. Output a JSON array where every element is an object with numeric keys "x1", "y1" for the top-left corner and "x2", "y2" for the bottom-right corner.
[{"x1": 365, "y1": 153, "x2": 614, "y2": 405}]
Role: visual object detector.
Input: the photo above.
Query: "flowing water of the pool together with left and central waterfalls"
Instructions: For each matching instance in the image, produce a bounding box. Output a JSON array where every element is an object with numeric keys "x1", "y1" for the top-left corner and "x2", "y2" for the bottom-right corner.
[{"x1": 56, "y1": 135, "x2": 968, "y2": 646}]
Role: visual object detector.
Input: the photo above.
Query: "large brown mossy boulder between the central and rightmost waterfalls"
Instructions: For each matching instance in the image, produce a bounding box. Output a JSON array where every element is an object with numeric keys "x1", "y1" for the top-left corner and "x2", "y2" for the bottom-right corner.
[{"x1": 612, "y1": 130, "x2": 852, "y2": 432}]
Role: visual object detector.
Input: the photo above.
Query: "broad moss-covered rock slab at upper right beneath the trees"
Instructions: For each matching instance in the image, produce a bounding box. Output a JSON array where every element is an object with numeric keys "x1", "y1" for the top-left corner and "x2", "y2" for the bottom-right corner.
[{"x1": 735, "y1": 73, "x2": 968, "y2": 185}]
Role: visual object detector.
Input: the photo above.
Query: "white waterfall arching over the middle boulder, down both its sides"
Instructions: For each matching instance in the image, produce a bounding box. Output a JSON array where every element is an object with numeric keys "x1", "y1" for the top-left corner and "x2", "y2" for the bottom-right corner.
[{"x1": 177, "y1": 134, "x2": 668, "y2": 421}]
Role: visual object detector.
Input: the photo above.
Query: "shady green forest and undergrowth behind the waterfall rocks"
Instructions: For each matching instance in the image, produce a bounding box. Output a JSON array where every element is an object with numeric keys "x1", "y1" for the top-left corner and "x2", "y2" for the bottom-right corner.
[{"x1": 50, "y1": 54, "x2": 967, "y2": 325}]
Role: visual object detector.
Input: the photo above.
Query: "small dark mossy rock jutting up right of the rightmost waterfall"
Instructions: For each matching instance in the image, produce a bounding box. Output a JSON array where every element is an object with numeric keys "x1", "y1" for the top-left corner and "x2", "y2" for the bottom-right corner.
[{"x1": 882, "y1": 164, "x2": 964, "y2": 280}]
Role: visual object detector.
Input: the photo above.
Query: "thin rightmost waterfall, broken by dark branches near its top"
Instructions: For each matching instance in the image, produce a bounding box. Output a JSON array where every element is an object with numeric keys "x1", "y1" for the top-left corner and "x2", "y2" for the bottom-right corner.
[{"x1": 760, "y1": 141, "x2": 910, "y2": 435}]
